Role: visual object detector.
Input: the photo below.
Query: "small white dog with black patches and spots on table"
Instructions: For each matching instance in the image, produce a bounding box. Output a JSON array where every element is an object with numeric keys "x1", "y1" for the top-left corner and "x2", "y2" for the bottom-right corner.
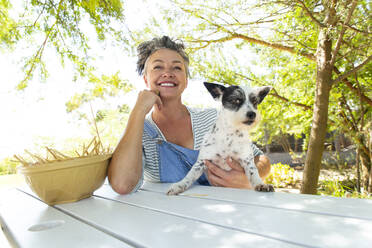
[{"x1": 167, "y1": 82, "x2": 274, "y2": 195}]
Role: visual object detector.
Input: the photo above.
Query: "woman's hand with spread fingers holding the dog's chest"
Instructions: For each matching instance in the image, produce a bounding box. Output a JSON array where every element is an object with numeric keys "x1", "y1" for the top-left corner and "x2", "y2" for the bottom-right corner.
[{"x1": 204, "y1": 158, "x2": 252, "y2": 189}]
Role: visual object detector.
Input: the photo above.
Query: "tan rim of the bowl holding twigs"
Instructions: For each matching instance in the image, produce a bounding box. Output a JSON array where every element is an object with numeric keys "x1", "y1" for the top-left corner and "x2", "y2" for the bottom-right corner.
[{"x1": 17, "y1": 154, "x2": 112, "y2": 175}]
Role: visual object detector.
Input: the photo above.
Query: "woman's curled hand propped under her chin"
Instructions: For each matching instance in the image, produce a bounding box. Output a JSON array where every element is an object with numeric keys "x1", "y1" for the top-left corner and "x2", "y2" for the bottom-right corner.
[{"x1": 133, "y1": 90, "x2": 162, "y2": 115}]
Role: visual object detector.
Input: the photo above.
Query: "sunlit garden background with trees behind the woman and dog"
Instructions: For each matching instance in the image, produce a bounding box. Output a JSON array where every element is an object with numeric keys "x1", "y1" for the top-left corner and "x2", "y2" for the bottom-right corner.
[{"x1": 0, "y1": 0, "x2": 372, "y2": 197}]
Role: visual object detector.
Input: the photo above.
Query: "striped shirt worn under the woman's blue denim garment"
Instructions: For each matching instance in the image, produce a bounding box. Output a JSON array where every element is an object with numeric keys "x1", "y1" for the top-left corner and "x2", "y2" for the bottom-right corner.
[{"x1": 141, "y1": 107, "x2": 263, "y2": 182}]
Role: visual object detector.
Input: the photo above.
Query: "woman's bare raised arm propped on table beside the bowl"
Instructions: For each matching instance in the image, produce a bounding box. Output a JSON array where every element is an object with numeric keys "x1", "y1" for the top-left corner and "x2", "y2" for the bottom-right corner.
[{"x1": 108, "y1": 90, "x2": 161, "y2": 194}]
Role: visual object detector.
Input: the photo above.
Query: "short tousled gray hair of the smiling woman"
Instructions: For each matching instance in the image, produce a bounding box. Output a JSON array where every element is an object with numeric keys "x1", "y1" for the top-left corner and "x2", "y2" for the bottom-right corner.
[{"x1": 137, "y1": 36, "x2": 189, "y2": 76}]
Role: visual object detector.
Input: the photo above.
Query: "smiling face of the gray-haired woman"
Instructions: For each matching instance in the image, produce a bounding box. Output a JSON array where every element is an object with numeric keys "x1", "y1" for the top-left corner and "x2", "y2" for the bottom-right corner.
[{"x1": 144, "y1": 48, "x2": 187, "y2": 98}]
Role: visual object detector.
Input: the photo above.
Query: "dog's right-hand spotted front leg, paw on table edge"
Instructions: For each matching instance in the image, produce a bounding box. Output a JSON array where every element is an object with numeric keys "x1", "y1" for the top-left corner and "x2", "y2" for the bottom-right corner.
[{"x1": 241, "y1": 159, "x2": 274, "y2": 192}]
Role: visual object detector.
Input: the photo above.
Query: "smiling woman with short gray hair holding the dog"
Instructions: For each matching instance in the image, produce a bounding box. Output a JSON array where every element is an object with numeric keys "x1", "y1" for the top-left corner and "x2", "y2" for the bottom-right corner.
[{"x1": 108, "y1": 36, "x2": 270, "y2": 194}]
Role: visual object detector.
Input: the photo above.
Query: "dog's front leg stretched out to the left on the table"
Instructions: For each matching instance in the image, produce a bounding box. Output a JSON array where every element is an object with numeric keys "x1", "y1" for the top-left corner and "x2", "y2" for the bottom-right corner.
[{"x1": 167, "y1": 160, "x2": 205, "y2": 195}]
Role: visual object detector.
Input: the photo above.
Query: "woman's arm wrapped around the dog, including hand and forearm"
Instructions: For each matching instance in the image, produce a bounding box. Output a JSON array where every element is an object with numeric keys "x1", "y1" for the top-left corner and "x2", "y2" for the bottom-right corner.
[{"x1": 205, "y1": 155, "x2": 271, "y2": 189}]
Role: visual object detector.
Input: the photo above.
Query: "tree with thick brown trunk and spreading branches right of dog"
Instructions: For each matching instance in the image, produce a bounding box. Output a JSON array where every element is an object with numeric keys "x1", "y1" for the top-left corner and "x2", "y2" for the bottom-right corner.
[{"x1": 130, "y1": 0, "x2": 372, "y2": 194}]
